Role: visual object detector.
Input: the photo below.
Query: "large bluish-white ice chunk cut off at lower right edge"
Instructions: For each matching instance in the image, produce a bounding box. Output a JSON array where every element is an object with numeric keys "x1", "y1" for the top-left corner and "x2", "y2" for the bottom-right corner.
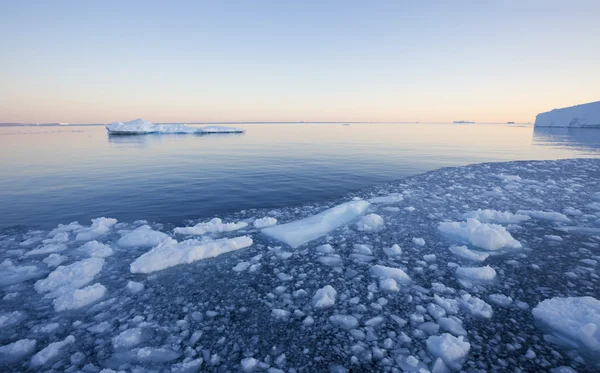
[{"x1": 531, "y1": 297, "x2": 600, "y2": 354}]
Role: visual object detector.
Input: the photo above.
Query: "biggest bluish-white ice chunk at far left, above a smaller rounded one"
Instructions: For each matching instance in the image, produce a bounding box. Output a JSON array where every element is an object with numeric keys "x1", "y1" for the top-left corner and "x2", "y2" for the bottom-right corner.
[{"x1": 34, "y1": 258, "x2": 104, "y2": 294}]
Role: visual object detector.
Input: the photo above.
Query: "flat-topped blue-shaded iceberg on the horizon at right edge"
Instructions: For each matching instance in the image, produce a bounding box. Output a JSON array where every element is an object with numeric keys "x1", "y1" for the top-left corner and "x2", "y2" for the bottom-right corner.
[{"x1": 535, "y1": 101, "x2": 600, "y2": 127}]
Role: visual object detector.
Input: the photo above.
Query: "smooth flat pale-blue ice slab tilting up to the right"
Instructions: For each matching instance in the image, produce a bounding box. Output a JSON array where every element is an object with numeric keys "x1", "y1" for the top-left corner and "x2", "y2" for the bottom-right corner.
[{"x1": 262, "y1": 200, "x2": 369, "y2": 248}]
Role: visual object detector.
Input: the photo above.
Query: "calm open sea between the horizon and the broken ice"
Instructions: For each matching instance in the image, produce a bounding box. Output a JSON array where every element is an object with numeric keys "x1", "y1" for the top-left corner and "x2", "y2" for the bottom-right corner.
[{"x1": 0, "y1": 123, "x2": 600, "y2": 228}]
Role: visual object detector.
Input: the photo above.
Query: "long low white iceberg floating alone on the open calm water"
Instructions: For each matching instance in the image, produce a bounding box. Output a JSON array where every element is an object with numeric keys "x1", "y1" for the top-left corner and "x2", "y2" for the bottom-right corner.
[{"x1": 106, "y1": 118, "x2": 245, "y2": 135}]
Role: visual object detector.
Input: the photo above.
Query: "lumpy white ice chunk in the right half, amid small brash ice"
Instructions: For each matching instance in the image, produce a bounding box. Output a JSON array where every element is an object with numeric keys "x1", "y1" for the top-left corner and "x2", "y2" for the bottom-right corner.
[{"x1": 438, "y1": 218, "x2": 521, "y2": 250}]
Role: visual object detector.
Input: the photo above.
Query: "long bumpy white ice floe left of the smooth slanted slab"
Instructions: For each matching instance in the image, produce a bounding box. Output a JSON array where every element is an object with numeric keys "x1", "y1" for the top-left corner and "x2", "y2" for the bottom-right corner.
[{"x1": 130, "y1": 236, "x2": 252, "y2": 273}]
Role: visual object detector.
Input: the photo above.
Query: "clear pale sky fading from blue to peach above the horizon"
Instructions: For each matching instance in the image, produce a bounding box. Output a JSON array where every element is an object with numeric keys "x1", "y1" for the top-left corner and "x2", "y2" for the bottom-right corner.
[{"x1": 0, "y1": 0, "x2": 600, "y2": 123}]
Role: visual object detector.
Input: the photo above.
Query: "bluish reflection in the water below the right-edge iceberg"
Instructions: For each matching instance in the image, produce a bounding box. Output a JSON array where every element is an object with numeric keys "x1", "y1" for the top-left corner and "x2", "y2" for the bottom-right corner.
[{"x1": 533, "y1": 127, "x2": 600, "y2": 151}]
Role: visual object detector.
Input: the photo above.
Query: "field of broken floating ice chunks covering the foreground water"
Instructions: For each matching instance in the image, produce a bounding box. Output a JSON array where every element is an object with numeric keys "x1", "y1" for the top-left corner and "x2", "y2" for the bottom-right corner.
[{"x1": 0, "y1": 159, "x2": 600, "y2": 373}]
